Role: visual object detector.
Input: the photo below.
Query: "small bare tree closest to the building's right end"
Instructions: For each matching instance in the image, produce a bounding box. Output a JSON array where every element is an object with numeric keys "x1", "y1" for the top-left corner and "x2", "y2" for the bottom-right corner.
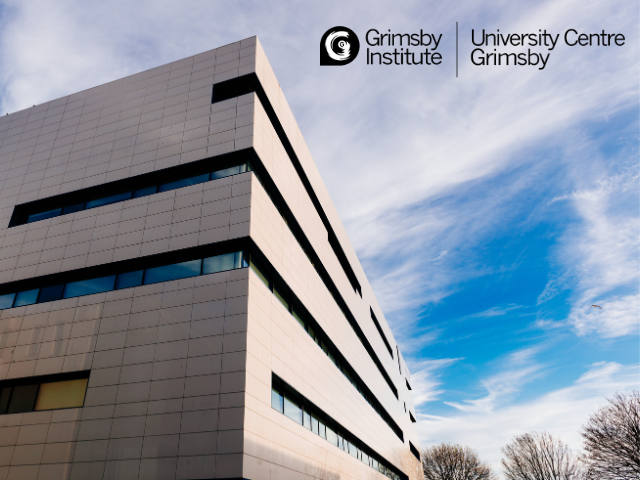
[{"x1": 422, "y1": 443, "x2": 496, "y2": 480}]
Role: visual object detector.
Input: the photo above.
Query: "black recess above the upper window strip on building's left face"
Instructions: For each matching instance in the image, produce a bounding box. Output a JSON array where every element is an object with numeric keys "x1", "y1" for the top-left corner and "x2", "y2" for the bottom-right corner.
[{"x1": 9, "y1": 151, "x2": 246, "y2": 227}]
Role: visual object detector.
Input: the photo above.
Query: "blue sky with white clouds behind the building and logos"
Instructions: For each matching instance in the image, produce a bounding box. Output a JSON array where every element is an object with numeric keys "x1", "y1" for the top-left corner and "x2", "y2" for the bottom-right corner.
[{"x1": 0, "y1": 0, "x2": 640, "y2": 474}]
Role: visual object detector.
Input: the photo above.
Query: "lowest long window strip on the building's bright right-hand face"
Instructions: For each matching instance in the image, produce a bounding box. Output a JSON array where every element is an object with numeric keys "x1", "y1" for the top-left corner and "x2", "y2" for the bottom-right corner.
[{"x1": 271, "y1": 374, "x2": 407, "y2": 480}]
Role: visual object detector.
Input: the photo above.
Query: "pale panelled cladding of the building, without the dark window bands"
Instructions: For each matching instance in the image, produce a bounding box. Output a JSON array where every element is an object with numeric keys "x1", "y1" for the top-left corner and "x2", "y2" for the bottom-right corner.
[{"x1": 0, "y1": 37, "x2": 418, "y2": 480}]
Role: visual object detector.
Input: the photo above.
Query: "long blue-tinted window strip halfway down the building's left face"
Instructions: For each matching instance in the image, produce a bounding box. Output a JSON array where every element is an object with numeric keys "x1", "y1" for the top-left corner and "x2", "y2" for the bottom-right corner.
[{"x1": 0, "y1": 252, "x2": 248, "y2": 310}]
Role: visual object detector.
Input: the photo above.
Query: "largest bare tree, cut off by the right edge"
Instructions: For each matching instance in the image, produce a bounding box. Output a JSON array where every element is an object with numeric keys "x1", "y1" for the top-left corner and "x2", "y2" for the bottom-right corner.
[{"x1": 581, "y1": 391, "x2": 640, "y2": 480}]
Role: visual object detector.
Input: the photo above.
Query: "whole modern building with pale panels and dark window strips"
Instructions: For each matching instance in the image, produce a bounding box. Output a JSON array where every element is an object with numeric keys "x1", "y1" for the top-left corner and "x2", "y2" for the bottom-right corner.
[{"x1": 0, "y1": 37, "x2": 419, "y2": 480}]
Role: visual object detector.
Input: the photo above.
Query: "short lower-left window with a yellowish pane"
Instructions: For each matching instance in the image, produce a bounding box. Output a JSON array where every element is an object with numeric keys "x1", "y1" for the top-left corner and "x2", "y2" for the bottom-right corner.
[{"x1": 0, "y1": 372, "x2": 89, "y2": 415}]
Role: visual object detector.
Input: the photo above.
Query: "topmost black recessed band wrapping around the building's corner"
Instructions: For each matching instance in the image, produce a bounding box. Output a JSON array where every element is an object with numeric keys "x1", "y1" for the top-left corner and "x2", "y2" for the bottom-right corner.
[{"x1": 211, "y1": 73, "x2": 362, "y2": 297}]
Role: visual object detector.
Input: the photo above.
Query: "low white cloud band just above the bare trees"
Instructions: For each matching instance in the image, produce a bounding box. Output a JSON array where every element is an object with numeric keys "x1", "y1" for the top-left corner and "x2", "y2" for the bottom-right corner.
[{"x1": 418, "y1": 362, "x2": 640, "y2": 474}]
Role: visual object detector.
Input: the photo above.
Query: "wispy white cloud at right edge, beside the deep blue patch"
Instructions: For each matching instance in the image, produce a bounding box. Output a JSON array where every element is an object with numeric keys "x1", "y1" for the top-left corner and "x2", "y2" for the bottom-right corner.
[{"x1": 538, "y1": 166, "x2": 640, "y2": 338}]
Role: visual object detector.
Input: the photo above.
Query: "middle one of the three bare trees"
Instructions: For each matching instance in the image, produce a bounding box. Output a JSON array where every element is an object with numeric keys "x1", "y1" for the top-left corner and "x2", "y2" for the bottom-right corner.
[{"x1": 501, "y1": 432, "x2": 583, "y2": 480}]
